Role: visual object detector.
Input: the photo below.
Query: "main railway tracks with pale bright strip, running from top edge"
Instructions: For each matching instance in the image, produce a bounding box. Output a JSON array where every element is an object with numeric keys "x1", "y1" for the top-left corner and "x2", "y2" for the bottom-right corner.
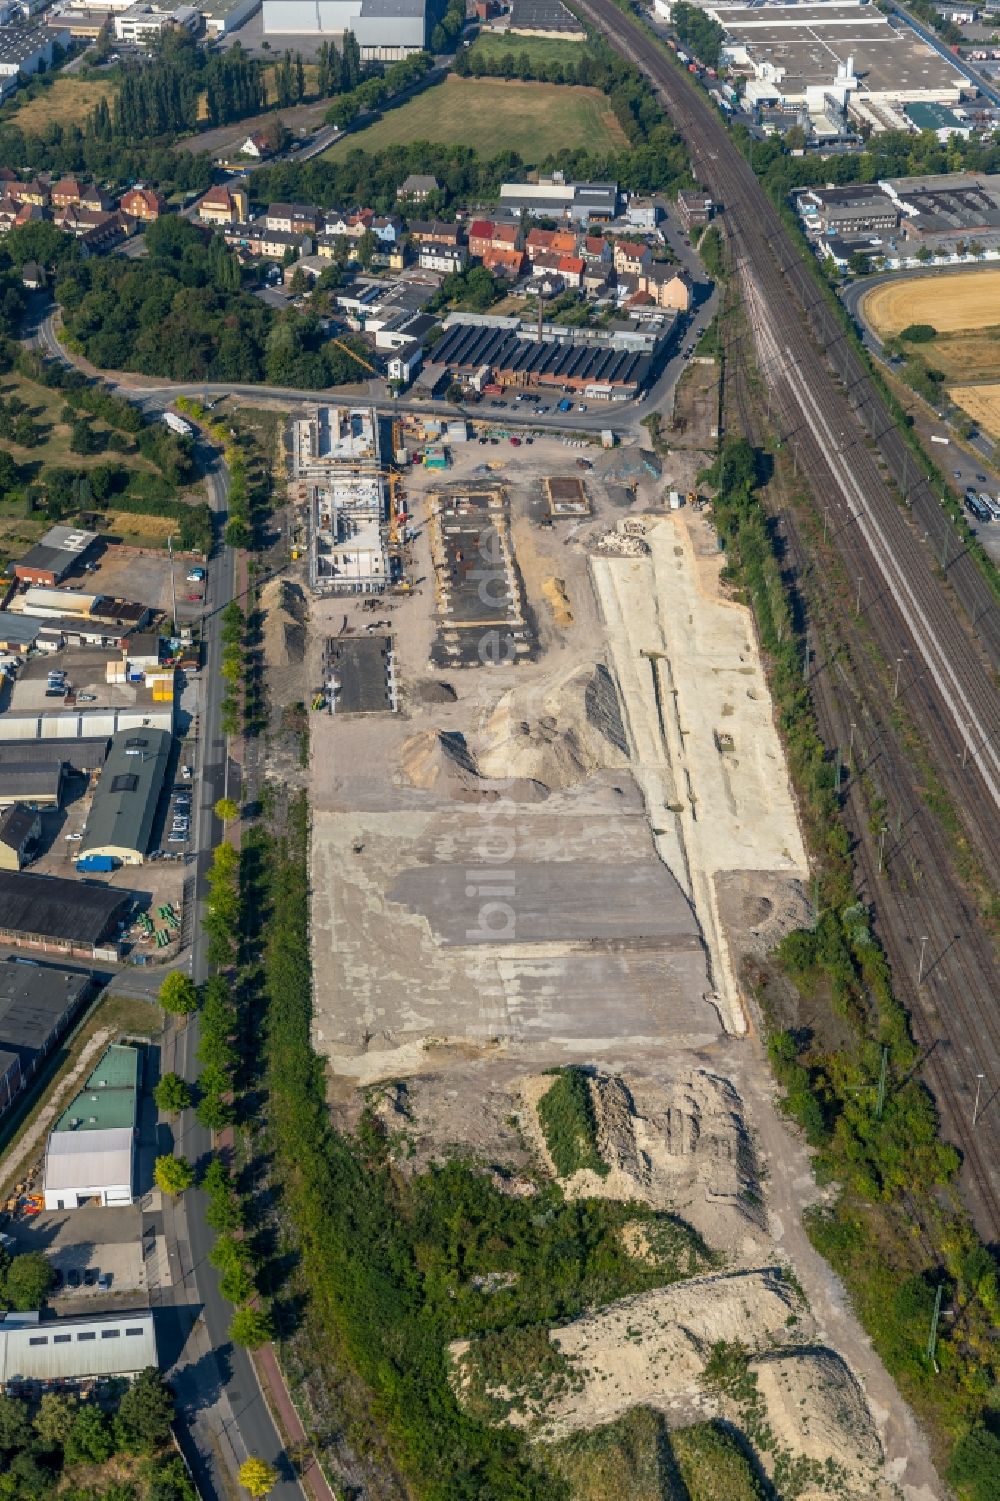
[{"x1": 573, "y1": 0, "x2": 1000, "y2": 840}]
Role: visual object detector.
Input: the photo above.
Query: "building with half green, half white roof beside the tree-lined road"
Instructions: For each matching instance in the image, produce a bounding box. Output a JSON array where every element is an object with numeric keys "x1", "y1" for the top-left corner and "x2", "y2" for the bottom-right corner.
[{"x1": 44, "y1": 1043, "x2": 140, "y2": 1210}]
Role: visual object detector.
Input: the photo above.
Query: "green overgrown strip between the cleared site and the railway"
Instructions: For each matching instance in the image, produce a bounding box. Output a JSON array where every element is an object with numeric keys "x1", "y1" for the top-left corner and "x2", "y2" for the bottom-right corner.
[{"x1": 699, "y1": 426, "x2": 1000, "y2": 1476}]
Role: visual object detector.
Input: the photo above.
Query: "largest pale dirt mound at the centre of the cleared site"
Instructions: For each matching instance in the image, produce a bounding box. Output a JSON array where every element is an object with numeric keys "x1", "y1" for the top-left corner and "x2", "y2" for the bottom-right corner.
[{"x1": 474, "y1": 668, "x2": 626, "y2": 791}]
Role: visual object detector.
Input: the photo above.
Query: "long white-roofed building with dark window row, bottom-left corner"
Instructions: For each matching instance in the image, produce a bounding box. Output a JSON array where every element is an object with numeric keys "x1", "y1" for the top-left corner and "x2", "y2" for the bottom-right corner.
[{"x1": 0, "y1": 1309, "x2": 159, "y2": 1394}]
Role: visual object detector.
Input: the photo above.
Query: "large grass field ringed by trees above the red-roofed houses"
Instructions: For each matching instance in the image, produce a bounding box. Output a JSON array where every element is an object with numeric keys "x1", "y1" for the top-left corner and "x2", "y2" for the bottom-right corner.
[{"x1": 324, "y1": 78, "x2": 626, "y2": 165}]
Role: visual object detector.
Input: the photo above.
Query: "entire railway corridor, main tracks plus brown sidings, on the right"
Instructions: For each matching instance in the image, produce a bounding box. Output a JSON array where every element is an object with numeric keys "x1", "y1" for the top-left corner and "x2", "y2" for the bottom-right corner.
[{"x1": 581, "y1": 0, "x2": 1000, "y2": 1238}]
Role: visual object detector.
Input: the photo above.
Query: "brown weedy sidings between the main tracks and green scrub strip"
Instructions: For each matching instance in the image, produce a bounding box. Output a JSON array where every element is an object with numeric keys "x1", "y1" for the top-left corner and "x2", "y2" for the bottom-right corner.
[{"x1": 727, "y1": 328, "x2": 1000, "y2": 1240}]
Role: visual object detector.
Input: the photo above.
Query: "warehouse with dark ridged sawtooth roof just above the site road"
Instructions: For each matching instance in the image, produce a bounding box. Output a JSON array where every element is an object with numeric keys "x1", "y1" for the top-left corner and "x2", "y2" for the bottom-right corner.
[{"x1": 428, "y1": 323, "x2": 653, "y2": 401}]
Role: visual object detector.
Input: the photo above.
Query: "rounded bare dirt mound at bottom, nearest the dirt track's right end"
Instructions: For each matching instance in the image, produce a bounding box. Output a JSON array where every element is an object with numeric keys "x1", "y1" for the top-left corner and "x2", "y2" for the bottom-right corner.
[{"x1": 751, "y1": 1349, "x2": 881, "y2": 1498}]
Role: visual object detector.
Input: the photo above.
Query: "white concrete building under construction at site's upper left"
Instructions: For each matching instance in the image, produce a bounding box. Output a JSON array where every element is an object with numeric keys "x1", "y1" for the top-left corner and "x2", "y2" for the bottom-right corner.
[{"x1": 291, "y1": 407, "x2": 389, "y2": 594}]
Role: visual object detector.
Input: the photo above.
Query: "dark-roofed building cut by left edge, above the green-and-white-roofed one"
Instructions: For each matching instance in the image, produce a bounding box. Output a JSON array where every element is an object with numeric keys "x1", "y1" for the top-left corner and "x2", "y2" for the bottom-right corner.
[{"x1": 0, "y1": 955, "x2": 93, "y2": 1112}]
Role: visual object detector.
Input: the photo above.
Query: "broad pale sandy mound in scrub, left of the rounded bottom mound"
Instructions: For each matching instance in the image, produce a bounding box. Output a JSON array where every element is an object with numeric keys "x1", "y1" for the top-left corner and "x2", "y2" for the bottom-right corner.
[{"x1": 450, "y1": 1271, "x2": 800, "y2": 1438}]
